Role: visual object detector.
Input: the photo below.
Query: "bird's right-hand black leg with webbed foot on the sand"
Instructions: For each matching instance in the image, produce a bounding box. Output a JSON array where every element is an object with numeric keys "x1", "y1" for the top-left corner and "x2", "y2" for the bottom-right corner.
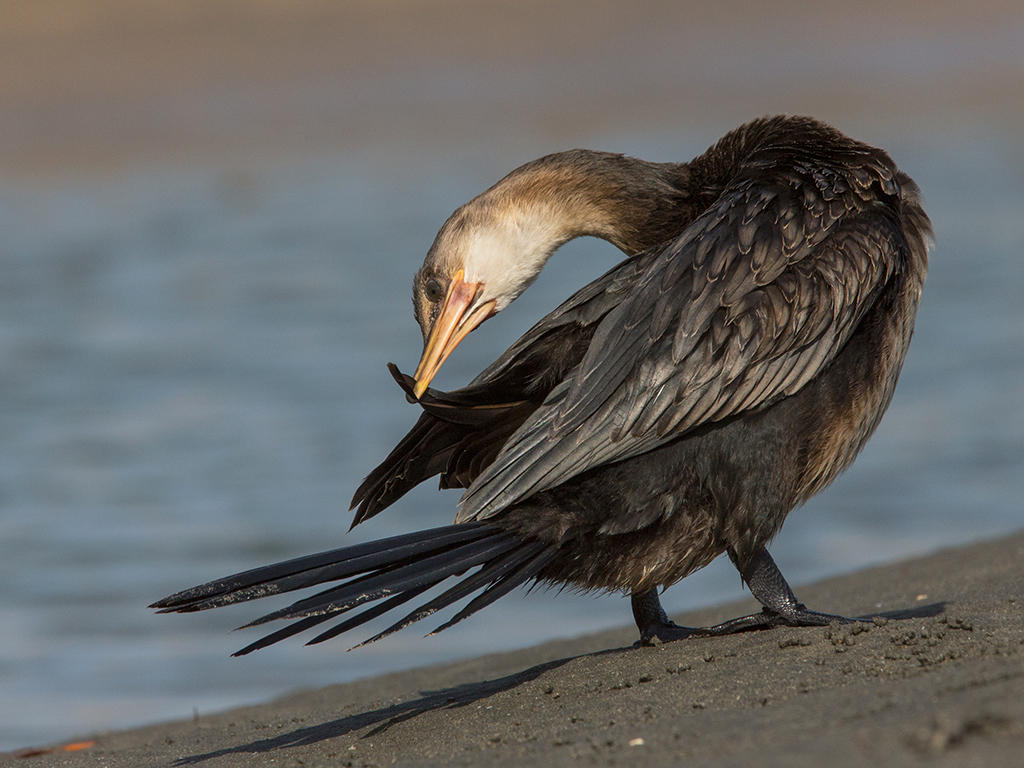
[{"x1": 696, "y1": 547, "x2": 862, "y2": 635}]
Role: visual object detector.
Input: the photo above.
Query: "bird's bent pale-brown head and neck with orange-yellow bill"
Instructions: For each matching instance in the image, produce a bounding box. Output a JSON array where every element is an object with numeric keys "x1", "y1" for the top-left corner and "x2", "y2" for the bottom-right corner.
[{"x1": 413, "y1": 150, "x2": 686, "y2": 397}]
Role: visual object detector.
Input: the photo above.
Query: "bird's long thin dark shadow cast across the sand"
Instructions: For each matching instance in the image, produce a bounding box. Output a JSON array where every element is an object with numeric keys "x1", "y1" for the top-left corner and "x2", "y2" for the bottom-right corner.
[{"x1": 174, "y1": 602, "x2": 946, "y2": 766}]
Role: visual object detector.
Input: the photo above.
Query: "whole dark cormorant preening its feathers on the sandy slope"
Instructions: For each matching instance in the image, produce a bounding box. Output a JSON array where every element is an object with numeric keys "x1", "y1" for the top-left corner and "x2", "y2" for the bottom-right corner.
[{"x1": 152, "y1": 116, "x2": 934, "y2": 655}]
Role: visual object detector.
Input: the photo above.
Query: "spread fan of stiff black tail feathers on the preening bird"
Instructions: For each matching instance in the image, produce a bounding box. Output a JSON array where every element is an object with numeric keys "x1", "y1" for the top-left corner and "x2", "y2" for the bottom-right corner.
[{"x1": 151, "y1": 523, "x2": 557, "y2": 655}]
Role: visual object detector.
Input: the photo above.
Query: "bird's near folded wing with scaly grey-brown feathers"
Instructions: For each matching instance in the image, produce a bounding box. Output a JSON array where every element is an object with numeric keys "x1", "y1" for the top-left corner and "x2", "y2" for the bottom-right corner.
[{"x1": 456, "y1": 176, "x2": 905, "y2": 522}]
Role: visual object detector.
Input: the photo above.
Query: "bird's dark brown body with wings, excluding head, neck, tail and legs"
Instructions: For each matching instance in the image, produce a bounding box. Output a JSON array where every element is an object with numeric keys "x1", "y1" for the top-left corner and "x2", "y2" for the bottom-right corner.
[{"x1": 353, "y1": 119, "x2": 931, "y2": 589}]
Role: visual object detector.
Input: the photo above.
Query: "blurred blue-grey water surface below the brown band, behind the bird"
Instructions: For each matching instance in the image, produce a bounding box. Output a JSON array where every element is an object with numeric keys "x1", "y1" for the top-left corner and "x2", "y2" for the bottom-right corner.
[{"x1": 0, "y1": 127, "x2": 1024, "y2": 749}]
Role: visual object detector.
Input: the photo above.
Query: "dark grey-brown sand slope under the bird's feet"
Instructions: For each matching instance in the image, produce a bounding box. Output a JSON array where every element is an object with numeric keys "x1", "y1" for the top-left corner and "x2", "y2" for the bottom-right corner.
[{"x1": 4, "y1": 534, "x2": 1024, "y2": 768}]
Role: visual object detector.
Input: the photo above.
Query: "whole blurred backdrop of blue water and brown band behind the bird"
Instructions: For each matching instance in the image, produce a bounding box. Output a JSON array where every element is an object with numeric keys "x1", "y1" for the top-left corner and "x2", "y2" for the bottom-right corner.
[{"x1": 0, "y1": 2, "x2": 1024, "y2": 749}]
